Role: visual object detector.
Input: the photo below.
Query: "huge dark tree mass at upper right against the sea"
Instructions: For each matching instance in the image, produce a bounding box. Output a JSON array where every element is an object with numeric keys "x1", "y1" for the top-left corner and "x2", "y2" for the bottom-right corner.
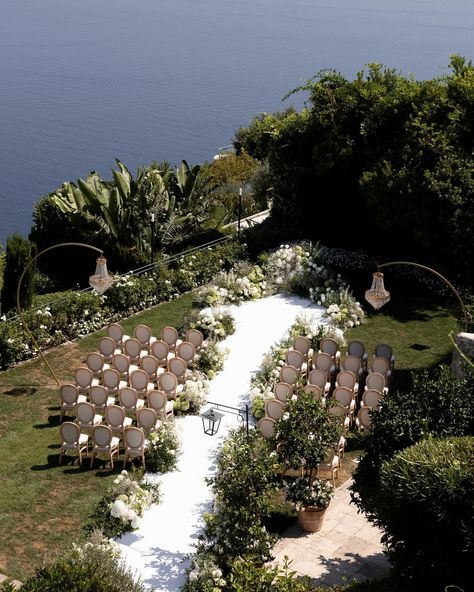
[{"x1": 237, "y1": 56, "x2": 474, "y2": 282}]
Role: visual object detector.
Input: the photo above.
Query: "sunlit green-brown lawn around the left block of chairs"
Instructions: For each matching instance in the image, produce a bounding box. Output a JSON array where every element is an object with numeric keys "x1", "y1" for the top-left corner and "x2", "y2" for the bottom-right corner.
[{"x1": 0, "y1": 295, "x2": 192, "y2": 580}]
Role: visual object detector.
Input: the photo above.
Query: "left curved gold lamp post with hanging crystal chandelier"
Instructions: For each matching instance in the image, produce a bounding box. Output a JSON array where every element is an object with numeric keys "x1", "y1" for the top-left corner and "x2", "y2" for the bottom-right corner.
[{"x1": 16, "y1": 243, "x2": 114, "y2": 386}]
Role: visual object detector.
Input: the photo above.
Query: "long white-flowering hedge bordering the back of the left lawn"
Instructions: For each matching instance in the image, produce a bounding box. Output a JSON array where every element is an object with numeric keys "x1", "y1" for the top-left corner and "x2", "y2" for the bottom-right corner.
[{"x1": 0, "y1": 242, "x2": 245, "y2": 370}]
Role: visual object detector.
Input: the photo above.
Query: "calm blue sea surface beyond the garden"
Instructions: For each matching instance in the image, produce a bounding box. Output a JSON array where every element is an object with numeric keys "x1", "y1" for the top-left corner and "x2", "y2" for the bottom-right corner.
[{"x1": 0, "y1": 0, "x2": 474, "y2": 243}]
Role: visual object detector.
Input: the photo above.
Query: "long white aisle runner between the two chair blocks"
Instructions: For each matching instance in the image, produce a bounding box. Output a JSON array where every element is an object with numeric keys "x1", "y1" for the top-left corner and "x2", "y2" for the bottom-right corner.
[{"x1": 120, "y1": 295, "x2": 324, "y2": 592}]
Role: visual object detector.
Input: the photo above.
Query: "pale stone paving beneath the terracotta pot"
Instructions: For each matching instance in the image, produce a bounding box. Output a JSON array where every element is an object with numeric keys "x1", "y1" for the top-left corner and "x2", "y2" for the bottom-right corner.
[{"x1": 273, "y1": 479, "x2": 390, "y2": 586}]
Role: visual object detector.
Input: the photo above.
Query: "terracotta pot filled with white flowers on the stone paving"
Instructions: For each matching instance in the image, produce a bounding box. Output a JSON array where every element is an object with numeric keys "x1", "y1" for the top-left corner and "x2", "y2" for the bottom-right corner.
[{"x1": 285, "y1": 475, "x2": 334, "y2": 532}]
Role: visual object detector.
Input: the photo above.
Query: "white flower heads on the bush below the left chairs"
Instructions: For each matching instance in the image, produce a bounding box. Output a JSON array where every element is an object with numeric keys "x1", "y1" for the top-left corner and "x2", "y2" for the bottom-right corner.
[{"x1": 109, "y1": 471, "x2": 153, "y2": 530}]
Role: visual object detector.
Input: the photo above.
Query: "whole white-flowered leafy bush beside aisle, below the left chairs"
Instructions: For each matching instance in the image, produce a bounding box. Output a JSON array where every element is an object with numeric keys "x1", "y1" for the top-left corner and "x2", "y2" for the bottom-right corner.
[{"x1": 85, "y1": 471, "x2": 159, "y2": 537}]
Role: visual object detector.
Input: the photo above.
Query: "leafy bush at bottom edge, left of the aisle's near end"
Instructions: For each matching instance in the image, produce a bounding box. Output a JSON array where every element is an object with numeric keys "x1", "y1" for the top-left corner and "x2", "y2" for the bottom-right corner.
[{"x1": 21, "y1": 533, "x2": 145, "y2": 592}]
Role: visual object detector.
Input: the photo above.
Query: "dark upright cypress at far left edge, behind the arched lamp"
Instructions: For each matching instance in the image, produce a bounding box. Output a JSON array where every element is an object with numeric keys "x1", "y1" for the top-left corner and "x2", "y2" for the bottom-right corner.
[{"x1": 1, "y1": 234, "x2": 36, "y2": 314}]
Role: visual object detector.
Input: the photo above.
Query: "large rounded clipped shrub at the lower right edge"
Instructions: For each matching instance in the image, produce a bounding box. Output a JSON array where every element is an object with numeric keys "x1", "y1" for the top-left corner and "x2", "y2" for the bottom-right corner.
[{"x1": 377, "y1": 437, "x2": 474, "y2": 590}]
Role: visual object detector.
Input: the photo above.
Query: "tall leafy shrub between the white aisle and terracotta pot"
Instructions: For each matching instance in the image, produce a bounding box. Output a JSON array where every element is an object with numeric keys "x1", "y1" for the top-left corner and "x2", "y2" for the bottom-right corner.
[{"x1": 202, "y1": 430, "x2": 276, "y2": 569}]
